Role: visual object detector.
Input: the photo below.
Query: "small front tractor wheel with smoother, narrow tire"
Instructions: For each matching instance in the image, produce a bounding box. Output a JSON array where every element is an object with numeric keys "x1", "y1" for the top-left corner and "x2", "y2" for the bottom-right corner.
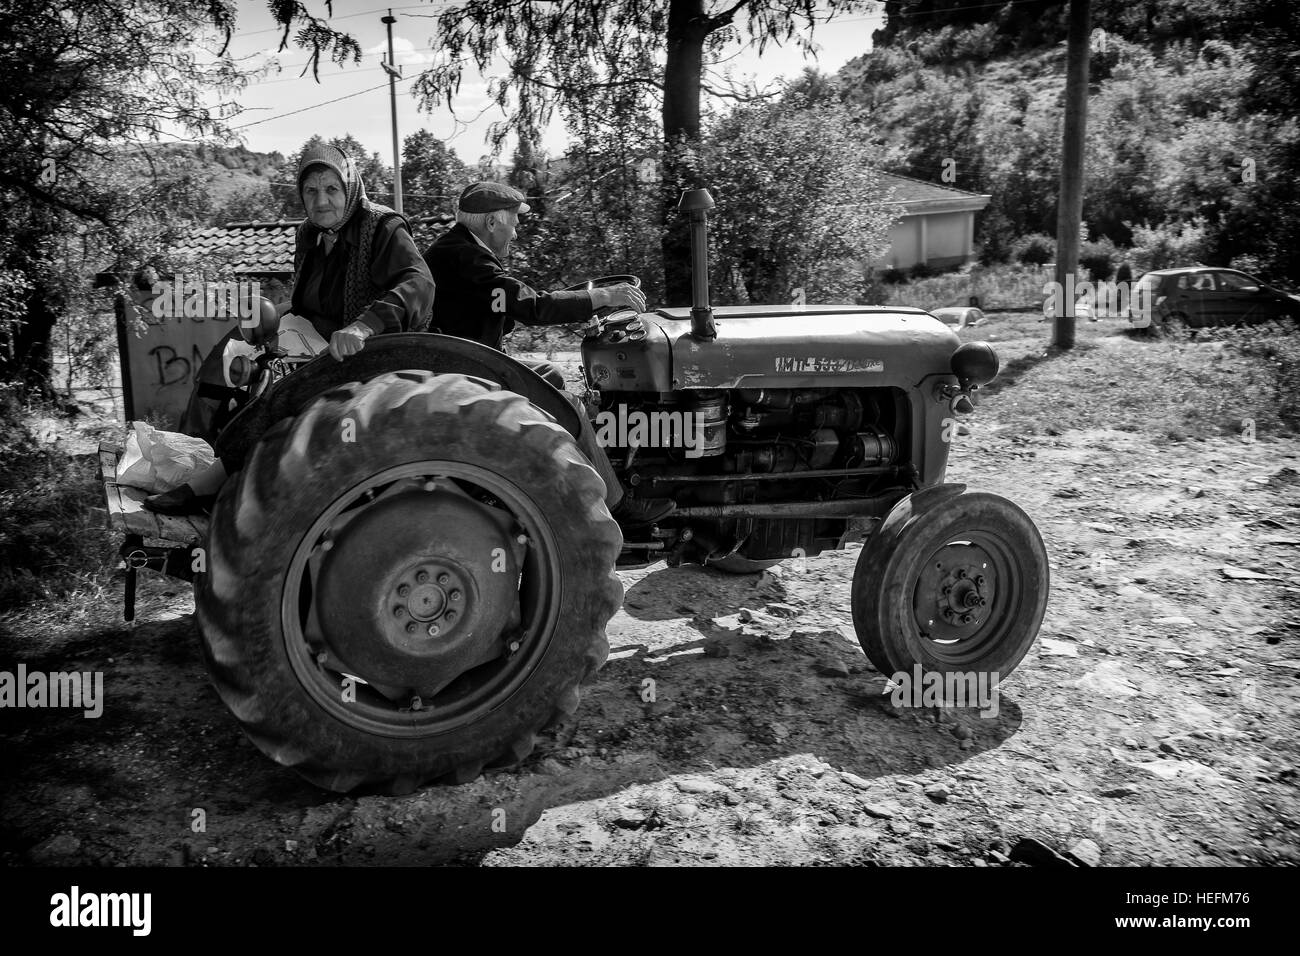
[{"x1": 853, "y1": 492, "x2": 1049, "y2": 679}]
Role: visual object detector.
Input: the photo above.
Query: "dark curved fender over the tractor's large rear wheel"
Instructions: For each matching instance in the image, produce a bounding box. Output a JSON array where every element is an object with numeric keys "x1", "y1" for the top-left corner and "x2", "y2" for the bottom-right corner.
[{"x1": 216, "y1": 332, "x2": 581, "y2": 462}]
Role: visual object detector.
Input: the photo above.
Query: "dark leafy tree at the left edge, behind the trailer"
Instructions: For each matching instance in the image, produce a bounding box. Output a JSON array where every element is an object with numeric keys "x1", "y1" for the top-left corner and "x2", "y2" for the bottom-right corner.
[{"x1": 0, "y1": 0, "x2": 360, "y2": 397}]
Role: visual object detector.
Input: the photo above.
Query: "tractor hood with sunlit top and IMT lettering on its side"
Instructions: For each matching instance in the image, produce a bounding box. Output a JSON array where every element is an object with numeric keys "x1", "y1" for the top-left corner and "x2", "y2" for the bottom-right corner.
[{"x1": 584, "y1": 306, "x2": 959, "y2": 392}]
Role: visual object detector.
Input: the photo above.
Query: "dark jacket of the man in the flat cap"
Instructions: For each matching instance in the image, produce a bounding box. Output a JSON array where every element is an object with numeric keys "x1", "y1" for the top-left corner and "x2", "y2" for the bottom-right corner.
[{"x1": 424, "y1": 222, "x2": 593, "y2": 349}]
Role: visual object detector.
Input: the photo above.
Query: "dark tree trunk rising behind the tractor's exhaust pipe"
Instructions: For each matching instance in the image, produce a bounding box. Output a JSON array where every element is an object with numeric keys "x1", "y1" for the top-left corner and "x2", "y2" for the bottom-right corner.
[{"x1": 662, "y1": 0, "x2": 711, "y2": 306}]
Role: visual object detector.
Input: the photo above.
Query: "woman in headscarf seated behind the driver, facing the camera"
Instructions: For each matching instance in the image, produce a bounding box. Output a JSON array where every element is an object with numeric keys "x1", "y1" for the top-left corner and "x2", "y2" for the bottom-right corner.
[{"x1": 144, "y1": 144, "x2": 433, "y2": 515}]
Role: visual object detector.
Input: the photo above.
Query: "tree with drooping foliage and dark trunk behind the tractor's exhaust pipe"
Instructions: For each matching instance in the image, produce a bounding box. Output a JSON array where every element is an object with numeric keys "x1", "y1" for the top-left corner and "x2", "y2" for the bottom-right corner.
[{"x1": 275, "y1": 0, "x2": 875, "y2": 303}]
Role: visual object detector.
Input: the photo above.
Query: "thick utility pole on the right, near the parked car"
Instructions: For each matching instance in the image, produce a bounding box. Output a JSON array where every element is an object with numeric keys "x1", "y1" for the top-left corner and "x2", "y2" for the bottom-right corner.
[{"x1": 1052, "y1": 0, "x2": 1092, "y2": 349}]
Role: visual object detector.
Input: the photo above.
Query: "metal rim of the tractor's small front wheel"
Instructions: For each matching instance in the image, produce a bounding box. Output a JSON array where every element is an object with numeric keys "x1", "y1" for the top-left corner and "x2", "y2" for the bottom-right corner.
[{"x1": 911, "y1": 531, "x2": 1026, "y2": 666}]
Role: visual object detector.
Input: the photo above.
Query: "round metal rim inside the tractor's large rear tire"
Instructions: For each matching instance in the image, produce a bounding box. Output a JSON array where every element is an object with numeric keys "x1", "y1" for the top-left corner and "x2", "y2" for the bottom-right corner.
[{"x1": 281, "y1": 460, "x2": 562, "y2": 737}]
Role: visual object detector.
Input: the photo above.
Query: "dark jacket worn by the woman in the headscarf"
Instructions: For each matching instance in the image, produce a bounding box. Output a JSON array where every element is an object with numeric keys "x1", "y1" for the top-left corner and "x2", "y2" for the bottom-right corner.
[{"x1": 293, "y1": 206, "x2": 434, "y2": 342}]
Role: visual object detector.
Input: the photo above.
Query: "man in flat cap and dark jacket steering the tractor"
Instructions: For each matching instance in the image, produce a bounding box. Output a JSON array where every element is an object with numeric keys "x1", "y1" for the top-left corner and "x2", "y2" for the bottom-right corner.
[{"x1": 424, "y1": 182, "x2": 673, "y2": 528}]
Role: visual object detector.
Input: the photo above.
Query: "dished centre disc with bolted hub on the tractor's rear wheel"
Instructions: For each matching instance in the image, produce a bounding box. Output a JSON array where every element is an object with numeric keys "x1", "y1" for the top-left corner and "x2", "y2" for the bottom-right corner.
[{"x1": 311, "y1": 481, "x2": 525, "y2": 700}]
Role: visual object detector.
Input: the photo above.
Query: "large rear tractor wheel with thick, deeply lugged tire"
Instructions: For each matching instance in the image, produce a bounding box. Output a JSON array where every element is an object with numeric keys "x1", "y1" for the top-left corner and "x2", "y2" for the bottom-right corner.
[{"x1": 195, "y1": 371, "x2": 623, "y2": 793}]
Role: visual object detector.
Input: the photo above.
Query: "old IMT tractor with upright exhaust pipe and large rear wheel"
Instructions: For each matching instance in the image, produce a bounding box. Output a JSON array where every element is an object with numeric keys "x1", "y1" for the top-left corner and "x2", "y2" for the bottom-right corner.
[{"x1": 111, "y1": 190, "x2": 1048, "y2": 792}]
